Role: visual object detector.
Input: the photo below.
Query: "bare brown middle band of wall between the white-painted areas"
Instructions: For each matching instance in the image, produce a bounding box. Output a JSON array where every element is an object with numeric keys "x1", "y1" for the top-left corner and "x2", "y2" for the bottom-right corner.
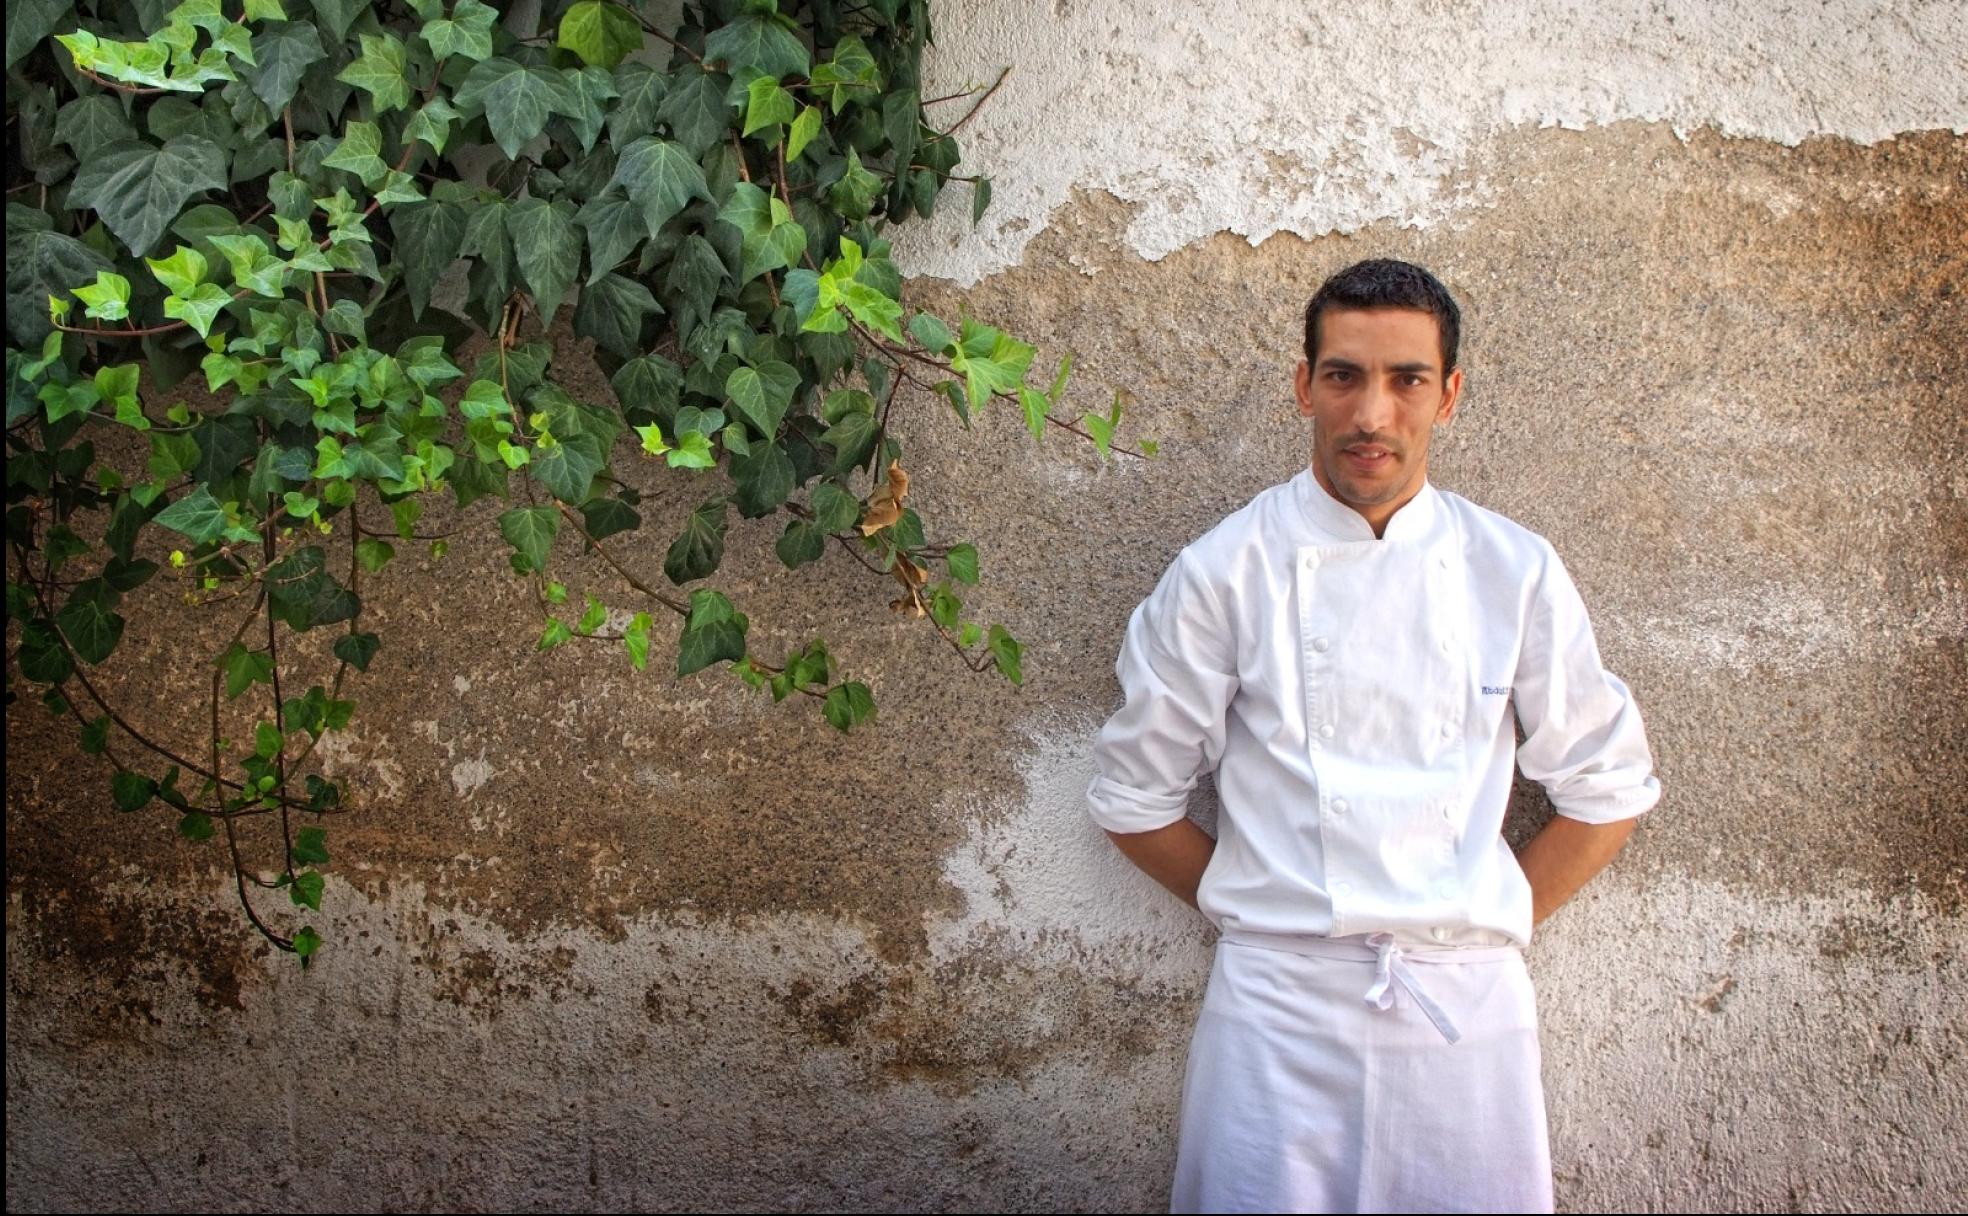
[{"x1": 6, "y1": 124, "x2": 1968, "y2": 1023}]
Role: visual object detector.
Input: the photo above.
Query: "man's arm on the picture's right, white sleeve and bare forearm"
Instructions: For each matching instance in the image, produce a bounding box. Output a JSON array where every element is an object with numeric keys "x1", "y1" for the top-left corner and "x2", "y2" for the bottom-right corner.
[{"x1": 1513, "y1": 557, "x2": 1661, "y2": 925}]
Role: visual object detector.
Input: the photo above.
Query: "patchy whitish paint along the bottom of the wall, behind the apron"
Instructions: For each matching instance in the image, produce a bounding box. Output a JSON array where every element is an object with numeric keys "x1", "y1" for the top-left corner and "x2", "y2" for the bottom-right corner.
[{"x1": 8, "y1": 720, "x2": 1968, "y2": 1210}]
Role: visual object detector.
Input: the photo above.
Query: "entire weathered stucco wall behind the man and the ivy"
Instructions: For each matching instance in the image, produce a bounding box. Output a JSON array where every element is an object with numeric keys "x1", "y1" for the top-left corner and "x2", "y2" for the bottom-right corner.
[{"x1": 6, "y1": 4, "x2": 1968, "y2": 1210}]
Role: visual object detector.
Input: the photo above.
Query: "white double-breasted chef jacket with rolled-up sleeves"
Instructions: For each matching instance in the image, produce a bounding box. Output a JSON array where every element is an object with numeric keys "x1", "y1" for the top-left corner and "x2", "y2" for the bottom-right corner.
[{"x1": 1086, "y1": 468, "x2": 1661, "y2": 946}]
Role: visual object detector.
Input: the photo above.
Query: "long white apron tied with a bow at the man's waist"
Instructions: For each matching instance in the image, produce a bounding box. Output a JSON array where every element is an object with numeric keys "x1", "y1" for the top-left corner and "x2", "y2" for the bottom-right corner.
[{"x1": 1169, "y1": 933, "x2": 1551, "y2": 1212}]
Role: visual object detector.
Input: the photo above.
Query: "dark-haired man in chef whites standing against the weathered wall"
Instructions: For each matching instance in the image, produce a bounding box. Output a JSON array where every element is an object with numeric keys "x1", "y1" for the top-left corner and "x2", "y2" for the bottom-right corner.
[{"x1": 1086, "y1": 260, "x2": 1659, "y2": 1212}]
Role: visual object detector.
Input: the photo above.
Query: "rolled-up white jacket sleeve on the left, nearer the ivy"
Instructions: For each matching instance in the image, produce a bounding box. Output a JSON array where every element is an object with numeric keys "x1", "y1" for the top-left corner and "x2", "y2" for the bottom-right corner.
[{"x1": 1086, "y1": 549, "x2": 1238, "y2": 832}]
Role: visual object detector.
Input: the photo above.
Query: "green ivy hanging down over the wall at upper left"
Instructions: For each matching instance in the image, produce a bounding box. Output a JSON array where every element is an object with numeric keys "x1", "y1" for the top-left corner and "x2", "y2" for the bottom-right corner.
[{"x1": 6, "y1": 0, "x2": 1155, "y2": 964}]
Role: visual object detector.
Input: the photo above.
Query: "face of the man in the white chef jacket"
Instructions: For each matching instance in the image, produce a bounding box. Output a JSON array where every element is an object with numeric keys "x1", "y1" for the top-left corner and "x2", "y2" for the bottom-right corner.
[{"x1": 1297, "y1": 309, "x2": 1462, "y2": 535}]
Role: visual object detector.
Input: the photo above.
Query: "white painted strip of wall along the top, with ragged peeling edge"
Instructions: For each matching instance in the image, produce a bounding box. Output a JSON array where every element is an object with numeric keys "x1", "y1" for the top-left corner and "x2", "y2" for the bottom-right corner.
[{"x1": 895, "y1": 0, "x2": 1968, "y2": 285}]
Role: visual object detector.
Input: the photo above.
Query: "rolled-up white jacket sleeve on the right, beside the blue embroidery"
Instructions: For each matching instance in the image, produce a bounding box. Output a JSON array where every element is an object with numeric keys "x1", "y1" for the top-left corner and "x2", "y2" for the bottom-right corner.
[{"x1": 1511, "y1": 555, "x2": 1661, "y2": 822}]
